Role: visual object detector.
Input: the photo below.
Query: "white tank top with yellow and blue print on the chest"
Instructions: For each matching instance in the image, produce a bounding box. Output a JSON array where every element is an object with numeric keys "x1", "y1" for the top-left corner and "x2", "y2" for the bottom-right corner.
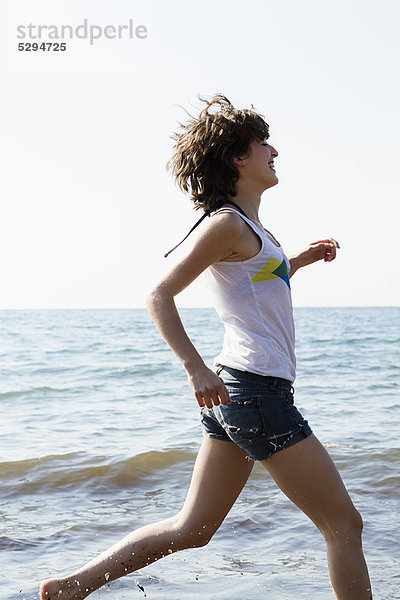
[{"x1": 207, "y1": 207, "x2": 296, "y2": 382}]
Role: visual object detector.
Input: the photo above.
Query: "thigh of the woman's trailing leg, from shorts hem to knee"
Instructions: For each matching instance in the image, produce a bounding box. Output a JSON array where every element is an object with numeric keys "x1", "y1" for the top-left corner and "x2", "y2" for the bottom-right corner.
[{"x1": 180, "y1": 436, "x2": 253, "y2": 531}]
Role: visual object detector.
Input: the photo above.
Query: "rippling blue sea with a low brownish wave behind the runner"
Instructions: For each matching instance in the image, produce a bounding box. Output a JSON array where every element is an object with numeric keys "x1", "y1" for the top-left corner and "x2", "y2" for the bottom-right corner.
[{"x1": 0, "y1": 308, "x2": 400, "y2": 600}]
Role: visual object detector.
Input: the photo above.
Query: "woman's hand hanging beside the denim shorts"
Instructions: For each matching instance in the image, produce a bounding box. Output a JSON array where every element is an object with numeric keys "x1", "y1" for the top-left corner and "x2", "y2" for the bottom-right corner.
[{"x1": 186, "y1": 365, "x2": 231, "y2": 408}]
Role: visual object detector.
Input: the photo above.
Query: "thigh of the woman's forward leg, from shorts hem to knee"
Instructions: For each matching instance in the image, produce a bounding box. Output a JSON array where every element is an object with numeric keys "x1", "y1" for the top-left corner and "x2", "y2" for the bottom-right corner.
[{"x1": 261, "y1": 434, "x2": 358, "y2": 533}]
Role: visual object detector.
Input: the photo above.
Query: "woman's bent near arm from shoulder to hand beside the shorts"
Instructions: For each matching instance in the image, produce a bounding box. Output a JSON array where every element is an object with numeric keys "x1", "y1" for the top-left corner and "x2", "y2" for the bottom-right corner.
[{"x1": 147, "y1": 214, "x2": 244, "y2": 407}]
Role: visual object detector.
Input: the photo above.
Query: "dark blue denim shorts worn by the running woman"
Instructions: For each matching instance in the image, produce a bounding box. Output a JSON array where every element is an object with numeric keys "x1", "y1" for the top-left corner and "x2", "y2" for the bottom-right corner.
[{"x1": 201, "y1": 365, "x2": 312, "y2": 460}]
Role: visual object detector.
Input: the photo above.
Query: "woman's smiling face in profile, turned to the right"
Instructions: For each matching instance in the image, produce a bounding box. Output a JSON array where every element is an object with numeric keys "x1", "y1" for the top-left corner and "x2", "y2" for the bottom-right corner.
[{"x1": 236, "y1": 140, "x2": 279, "y2": 190}]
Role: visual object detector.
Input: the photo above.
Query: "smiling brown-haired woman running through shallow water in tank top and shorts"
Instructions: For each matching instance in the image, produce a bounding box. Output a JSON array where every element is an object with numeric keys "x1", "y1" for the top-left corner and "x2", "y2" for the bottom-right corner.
[{"x1": 41, "y1": 95, "x2": 372, "y2": 600}]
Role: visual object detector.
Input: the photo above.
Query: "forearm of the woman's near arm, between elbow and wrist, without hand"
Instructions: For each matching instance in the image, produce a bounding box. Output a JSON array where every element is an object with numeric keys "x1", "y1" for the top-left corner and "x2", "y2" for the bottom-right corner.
[{"x1": 147, "y1": 287, "x2": 204, "y2": 369}]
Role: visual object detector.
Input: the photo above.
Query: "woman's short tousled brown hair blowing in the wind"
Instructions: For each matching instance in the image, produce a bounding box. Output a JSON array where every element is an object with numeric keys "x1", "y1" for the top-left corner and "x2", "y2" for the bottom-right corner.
[{"x1": 167, "y1": 94, "x2": 269, "y2": 210}]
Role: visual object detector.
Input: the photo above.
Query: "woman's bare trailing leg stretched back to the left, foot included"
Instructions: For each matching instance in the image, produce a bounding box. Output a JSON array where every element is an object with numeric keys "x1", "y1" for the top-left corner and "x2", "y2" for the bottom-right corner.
[{"x1": 40, "y1": 437, "x2": 253, "y2": 600}]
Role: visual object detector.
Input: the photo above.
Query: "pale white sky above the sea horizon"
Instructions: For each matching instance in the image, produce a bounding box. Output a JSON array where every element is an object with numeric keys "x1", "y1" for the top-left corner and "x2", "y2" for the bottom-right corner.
[{"x1": 0, "y1": 0, "x2": 400, "y2": 309}]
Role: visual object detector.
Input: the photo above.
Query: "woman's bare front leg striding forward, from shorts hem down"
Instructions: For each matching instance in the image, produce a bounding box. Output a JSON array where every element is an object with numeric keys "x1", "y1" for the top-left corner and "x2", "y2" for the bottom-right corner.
[{"x1": 262, "y1": 435, "x2": 372, "y2": 600}]
